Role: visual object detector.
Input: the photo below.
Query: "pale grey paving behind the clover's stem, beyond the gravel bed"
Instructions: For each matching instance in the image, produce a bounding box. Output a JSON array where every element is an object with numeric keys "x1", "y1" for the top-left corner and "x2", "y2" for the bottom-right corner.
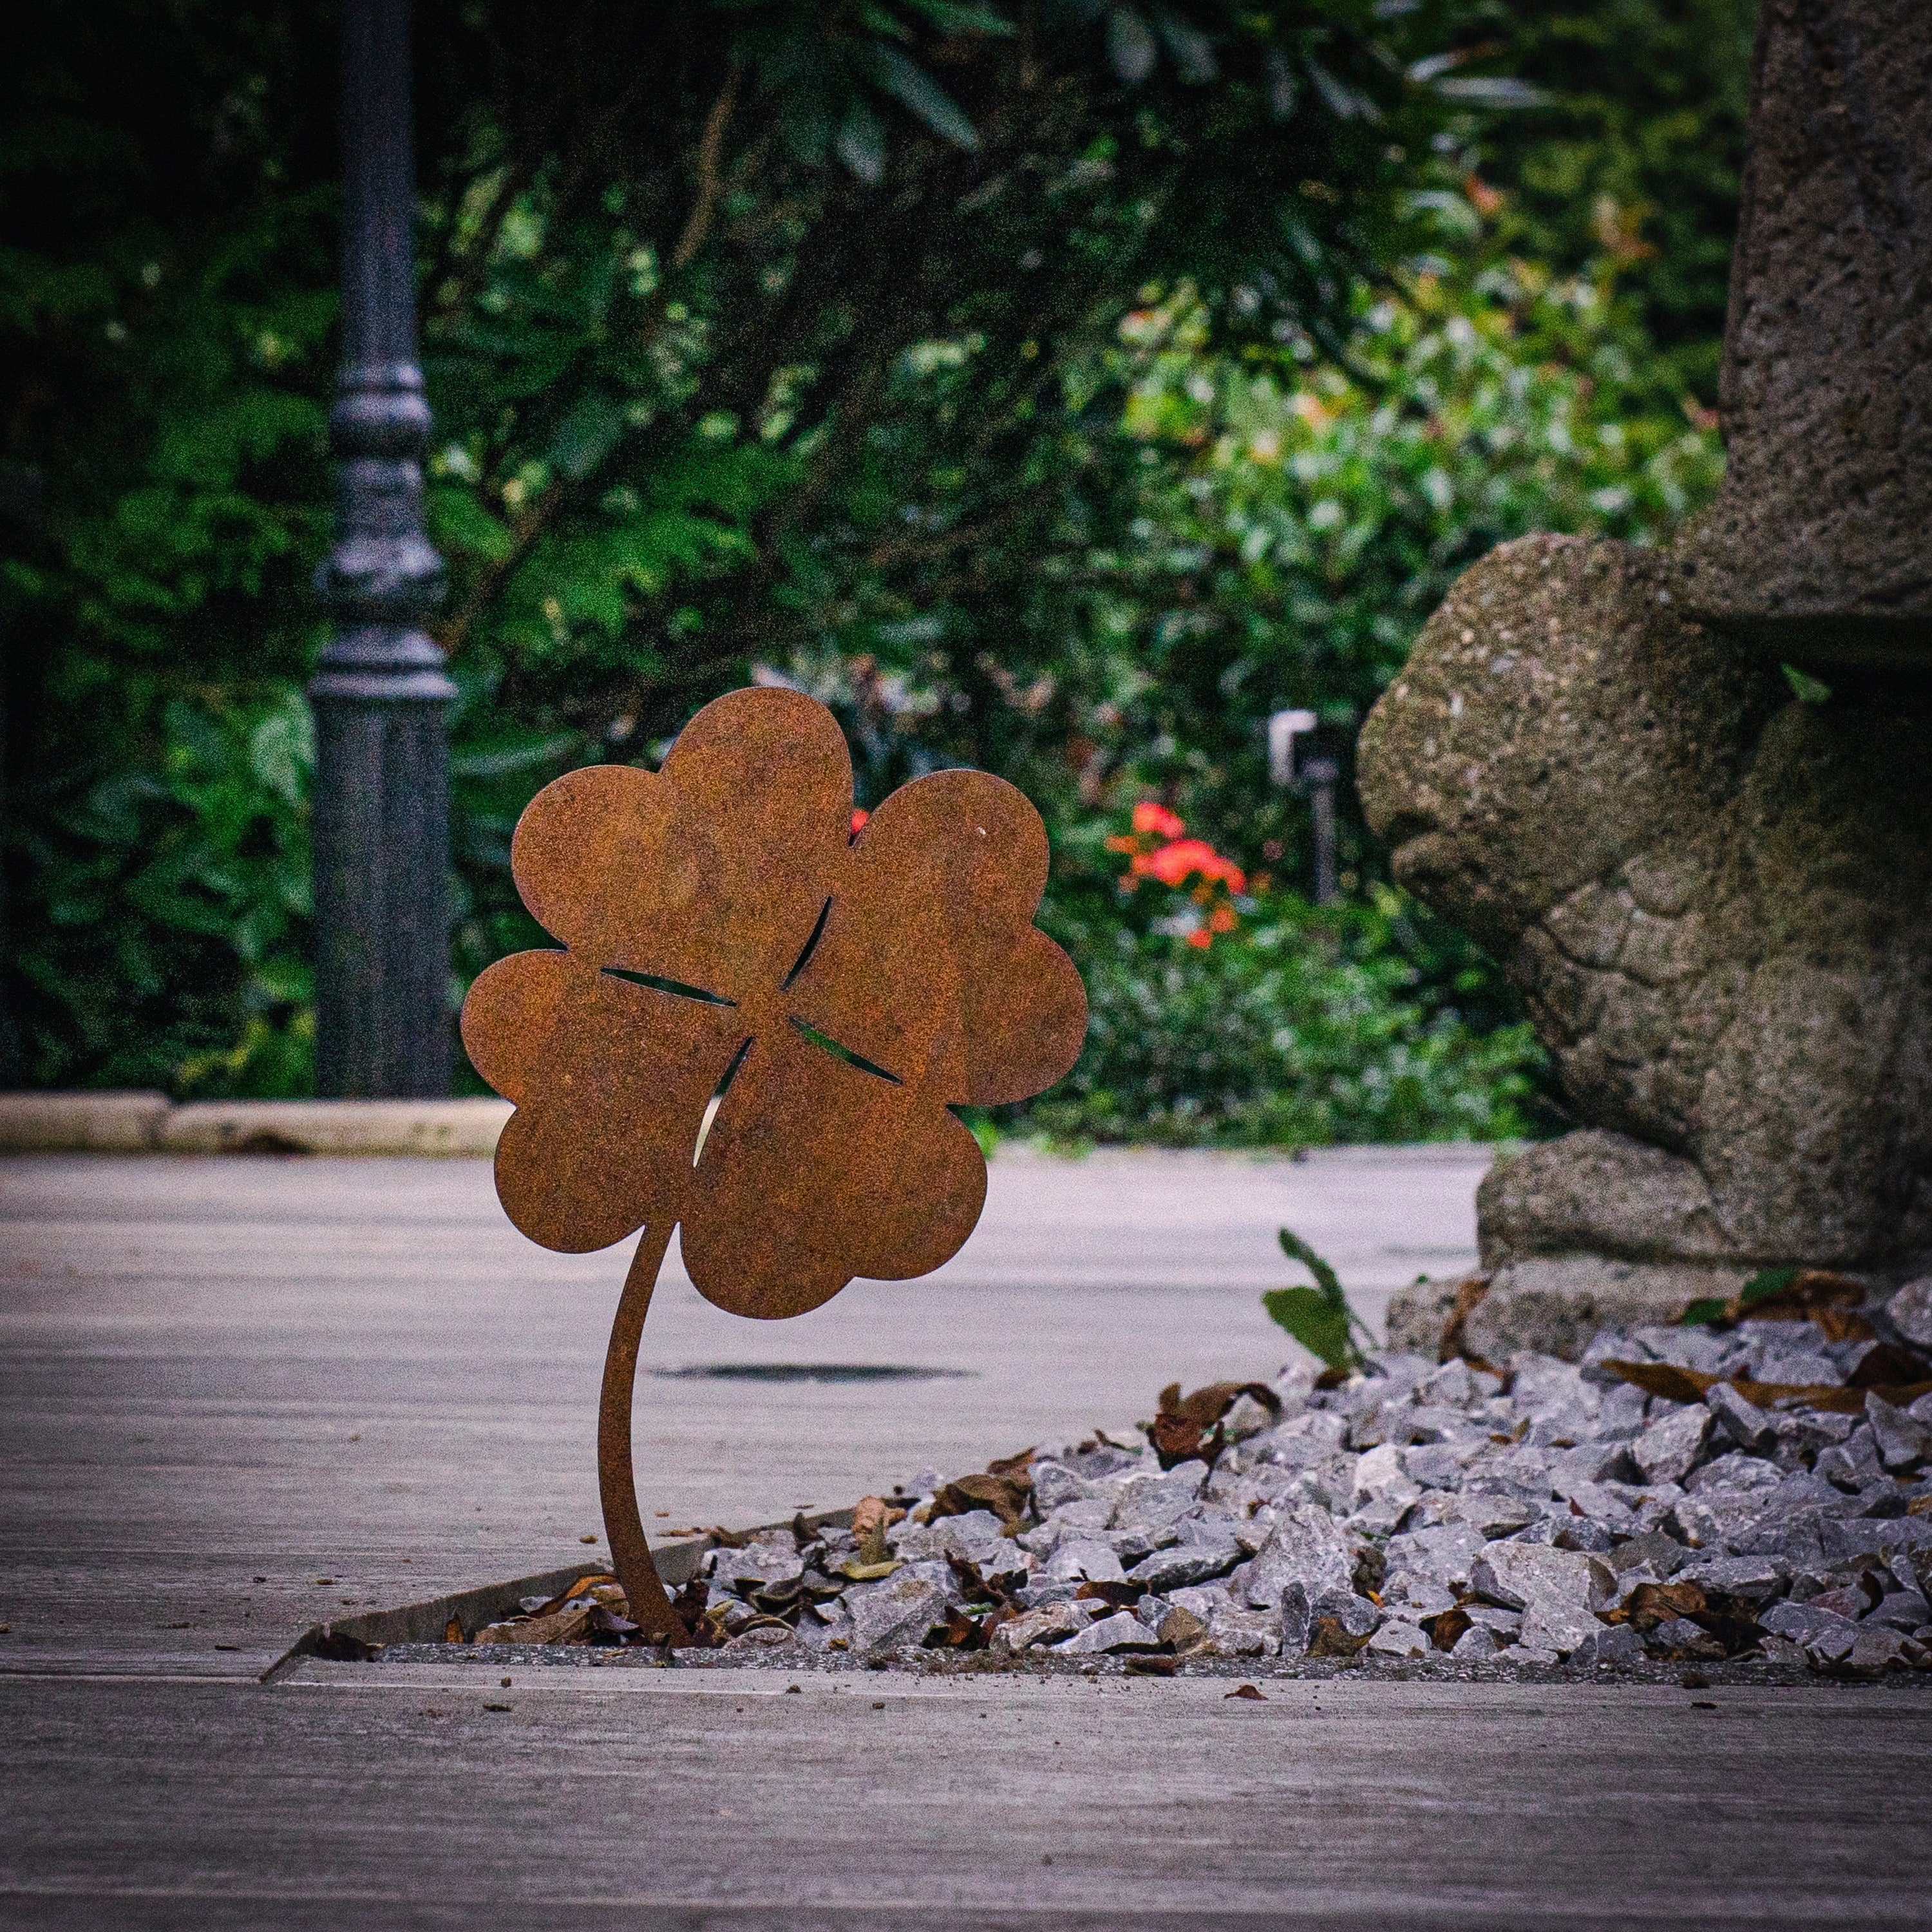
[{"x1": 0, "y1": 1151, "x2": 1482, "y2": 1667}]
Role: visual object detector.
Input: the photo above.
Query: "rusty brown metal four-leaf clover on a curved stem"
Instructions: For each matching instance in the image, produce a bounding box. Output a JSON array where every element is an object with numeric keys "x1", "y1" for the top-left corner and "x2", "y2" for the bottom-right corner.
[{"x1": 464, "y1": 690, "x2": 1086, "y2": 1642}]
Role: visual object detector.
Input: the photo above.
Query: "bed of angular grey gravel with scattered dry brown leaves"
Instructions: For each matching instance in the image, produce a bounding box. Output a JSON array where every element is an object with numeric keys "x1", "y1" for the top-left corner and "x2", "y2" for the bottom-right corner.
[{"x1": 388, "y1": 1285, "x2": 1932, "y2": 1687}]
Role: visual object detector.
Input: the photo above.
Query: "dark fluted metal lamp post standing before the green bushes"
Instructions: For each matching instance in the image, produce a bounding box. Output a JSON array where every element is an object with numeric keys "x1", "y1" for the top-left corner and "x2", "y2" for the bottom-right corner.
[{"x1": 309, "y1": 0, "x2": 456, "y2": 1099}]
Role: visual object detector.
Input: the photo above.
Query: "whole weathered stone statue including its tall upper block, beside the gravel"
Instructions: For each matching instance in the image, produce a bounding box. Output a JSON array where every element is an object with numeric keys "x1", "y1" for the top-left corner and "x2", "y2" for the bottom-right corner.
[{"x1": 1358, "y1": 0, "x2": 1932, "y2": 1356}]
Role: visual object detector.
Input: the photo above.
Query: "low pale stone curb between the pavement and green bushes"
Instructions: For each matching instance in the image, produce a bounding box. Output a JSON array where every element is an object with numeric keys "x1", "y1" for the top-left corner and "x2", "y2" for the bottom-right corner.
[{"x1": 0, "y1": 1094, "x2": 1513, "y2": 1167}]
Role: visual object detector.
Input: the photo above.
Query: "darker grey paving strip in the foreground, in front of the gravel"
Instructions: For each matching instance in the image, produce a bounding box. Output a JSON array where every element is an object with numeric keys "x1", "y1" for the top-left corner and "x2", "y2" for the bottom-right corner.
[{"x1": 15, "y1": 1665, "x2": 1932, "y2": 1932}]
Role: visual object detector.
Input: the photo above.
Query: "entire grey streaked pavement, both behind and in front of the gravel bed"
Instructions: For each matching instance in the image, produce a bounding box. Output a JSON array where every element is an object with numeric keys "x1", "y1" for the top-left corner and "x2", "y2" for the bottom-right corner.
[{"x1": 0, "y1": 1155, "x2": 1932, "y2": 1932}]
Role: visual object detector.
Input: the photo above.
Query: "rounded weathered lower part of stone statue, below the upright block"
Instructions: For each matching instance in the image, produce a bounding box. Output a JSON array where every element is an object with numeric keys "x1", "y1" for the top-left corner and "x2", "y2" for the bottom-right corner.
[{"x1": 1358, "y1": 537, "x2": 1932, "y2": 1352}]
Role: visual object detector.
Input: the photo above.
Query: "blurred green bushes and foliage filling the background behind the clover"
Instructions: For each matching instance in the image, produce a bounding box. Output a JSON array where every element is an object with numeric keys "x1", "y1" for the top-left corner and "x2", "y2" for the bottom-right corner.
[{"x1": 0, "y1": 0, "x2": 1750, "y2": 1140}]
